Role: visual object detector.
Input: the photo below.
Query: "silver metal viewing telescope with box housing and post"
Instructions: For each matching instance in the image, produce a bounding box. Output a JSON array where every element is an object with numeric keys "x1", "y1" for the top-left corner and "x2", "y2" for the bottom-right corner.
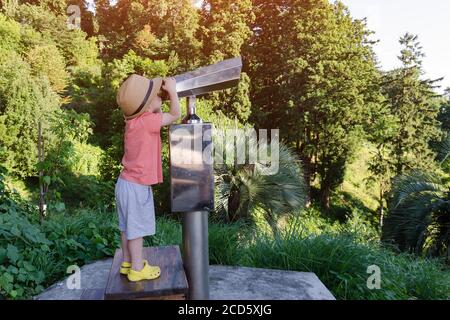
[{"x1": 169, "y1": 57, "x2": 242, "y2": 300}]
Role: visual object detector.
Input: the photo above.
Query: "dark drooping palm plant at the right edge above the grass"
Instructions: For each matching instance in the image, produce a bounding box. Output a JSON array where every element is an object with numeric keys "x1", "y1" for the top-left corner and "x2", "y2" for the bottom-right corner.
[{"x1": 382, "y1": 170, "x2": 450, "y2": 256}]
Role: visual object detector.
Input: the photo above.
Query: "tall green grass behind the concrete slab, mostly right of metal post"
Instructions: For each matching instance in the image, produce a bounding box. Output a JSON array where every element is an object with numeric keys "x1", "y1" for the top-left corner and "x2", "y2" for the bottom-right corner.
[{"x1": 151, "y1": 213, "x2": 450, "y2": 300}]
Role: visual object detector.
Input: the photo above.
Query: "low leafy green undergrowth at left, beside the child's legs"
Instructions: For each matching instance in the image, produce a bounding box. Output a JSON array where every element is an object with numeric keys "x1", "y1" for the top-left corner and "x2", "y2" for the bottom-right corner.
[{"x1": 0, "y1": 165, "x2": 119, "y2": 299}]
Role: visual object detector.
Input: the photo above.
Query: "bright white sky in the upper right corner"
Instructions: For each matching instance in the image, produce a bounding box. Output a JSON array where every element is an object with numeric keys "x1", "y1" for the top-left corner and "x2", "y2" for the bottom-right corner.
[{"x1": 341, "y1": 0, "x2": 450, "y2": 89}]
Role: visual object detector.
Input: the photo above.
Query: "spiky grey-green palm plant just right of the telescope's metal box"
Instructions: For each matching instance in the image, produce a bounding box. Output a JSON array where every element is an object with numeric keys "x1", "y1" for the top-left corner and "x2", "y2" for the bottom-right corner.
[{"x1": 215, "y1": 131, "x2": 307, "y2": 233}]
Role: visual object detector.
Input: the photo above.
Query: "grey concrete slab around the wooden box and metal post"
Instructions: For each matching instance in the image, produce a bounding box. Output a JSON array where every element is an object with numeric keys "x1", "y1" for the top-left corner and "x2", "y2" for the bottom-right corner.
[{"x1": 34, "y1": 259, "x2": 335, "y2": 300}]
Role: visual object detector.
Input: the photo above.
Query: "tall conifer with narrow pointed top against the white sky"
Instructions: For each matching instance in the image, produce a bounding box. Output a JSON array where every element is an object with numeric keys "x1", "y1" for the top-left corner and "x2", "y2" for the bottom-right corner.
[{"x1": 366, "y1": 34, "x2": 445, "y2": 226}]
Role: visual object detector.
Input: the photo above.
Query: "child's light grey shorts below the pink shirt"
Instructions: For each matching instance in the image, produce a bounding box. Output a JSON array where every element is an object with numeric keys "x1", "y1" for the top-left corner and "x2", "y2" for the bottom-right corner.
[{"x1": 115, "y1": 178, "x2": 156, "y2": 240}]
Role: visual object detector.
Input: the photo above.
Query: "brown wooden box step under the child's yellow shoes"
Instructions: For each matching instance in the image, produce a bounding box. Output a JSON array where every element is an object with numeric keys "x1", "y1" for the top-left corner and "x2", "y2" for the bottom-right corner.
[{"x1": 105, "y1": 246, "x2": 188, "y2": 300}]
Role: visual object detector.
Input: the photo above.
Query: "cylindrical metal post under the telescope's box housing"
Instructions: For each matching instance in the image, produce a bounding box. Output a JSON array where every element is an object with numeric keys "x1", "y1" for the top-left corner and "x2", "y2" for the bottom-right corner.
[{"x1": 183, "y1": 211, "x2": 209, "y2": 300}]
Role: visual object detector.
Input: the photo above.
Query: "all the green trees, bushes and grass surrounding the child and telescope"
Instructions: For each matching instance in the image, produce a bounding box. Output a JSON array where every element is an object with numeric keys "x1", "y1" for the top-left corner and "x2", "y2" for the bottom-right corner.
[{"x1": 0, "y1": 0, "x2": 450, "y2": 299}]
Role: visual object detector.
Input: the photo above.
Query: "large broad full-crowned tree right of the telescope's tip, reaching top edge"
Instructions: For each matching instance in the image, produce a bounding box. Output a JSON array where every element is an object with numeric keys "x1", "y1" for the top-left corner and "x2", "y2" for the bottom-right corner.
[{"x1": 244, "y1": 0, "x2": 378, "y2": 207}]
